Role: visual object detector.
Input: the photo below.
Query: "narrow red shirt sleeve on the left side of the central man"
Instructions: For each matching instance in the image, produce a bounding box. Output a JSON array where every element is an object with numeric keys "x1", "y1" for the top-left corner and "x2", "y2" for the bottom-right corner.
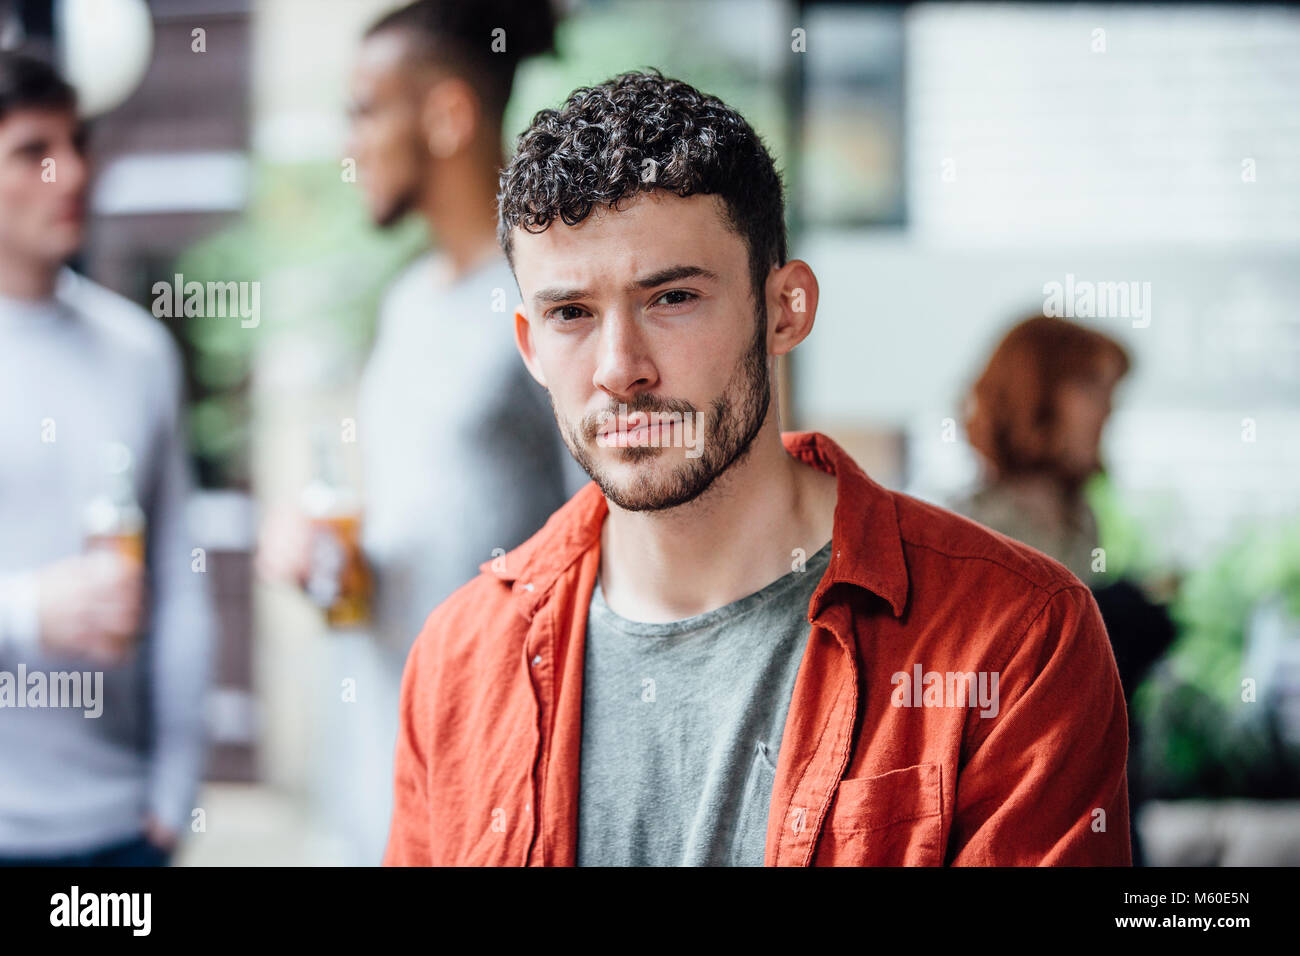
[{"x1": 384, "y1": 623, "x2": 432, "y2": 866}]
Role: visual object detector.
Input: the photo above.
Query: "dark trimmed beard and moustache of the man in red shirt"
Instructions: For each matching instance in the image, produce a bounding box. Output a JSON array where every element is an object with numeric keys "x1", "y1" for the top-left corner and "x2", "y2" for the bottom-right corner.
[{"x1": 551, "y1": 306, "x2": 772, "y2": 511}]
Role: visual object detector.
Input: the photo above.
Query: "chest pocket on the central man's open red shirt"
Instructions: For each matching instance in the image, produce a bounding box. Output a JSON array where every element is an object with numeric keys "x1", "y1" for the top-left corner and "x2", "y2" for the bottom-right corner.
[{"x1": 814, "y1": 763, "x2": 944, "y2": 866}]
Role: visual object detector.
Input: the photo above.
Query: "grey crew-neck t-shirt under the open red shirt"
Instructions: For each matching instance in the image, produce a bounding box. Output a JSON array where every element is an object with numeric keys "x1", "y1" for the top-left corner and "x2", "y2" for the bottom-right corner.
[{"x1": 577, "y1": 542, "x2": 831, "y2": 866}]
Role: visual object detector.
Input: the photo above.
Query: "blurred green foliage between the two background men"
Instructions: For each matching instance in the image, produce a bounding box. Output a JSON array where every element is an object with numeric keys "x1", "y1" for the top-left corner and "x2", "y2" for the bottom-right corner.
[{"x1": 176, "y1": 163, "x2": 428, "y2": 488}]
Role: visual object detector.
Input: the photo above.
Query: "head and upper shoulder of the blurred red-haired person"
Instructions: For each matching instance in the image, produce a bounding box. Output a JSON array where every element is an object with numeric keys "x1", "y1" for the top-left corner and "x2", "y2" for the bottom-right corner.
[{"x1": 957, "y1": 315, "x2": 1130, "y2": 583}]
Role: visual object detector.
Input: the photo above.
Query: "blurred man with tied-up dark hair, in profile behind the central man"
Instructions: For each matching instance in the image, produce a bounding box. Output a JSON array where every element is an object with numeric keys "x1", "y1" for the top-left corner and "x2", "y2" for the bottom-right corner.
[{"x1": 259, "y1": 0, "x2": 586, "y2": 864}]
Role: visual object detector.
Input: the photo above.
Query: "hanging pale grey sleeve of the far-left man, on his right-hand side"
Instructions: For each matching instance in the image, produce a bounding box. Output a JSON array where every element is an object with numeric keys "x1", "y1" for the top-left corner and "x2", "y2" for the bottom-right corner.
[{"x1": 148, "y1": 343, "x2": 215, "y2": 832}]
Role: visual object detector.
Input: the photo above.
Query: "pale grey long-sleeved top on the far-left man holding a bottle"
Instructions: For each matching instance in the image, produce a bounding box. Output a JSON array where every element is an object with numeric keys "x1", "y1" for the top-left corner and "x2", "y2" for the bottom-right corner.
[{"x1": 0, "y1": 271, "x2": 213, "y2": 856}]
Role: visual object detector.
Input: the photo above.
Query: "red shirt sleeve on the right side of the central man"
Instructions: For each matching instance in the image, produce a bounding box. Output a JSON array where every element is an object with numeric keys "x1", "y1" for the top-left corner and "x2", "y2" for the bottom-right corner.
[{"x1": 948, "y1": 585, "x2": 1132, "y2": 866}]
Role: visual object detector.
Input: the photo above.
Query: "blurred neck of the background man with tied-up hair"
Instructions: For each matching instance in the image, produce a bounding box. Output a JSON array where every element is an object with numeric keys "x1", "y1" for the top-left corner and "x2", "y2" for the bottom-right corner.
[{"x1": 421, "y1": 143, "x2": 501, "y2": 282}]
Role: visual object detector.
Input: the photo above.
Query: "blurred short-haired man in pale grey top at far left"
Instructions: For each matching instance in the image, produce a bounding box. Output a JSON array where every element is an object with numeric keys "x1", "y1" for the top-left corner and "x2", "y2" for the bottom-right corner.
[{"x1": 0, "y1": 51, "x2": 213, "y2": 865}]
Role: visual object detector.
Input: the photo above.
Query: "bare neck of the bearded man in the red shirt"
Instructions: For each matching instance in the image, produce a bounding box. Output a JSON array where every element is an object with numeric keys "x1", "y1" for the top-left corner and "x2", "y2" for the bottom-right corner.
[{"x1": 601, "y1": 419, "x2": 836, "y2": 622}]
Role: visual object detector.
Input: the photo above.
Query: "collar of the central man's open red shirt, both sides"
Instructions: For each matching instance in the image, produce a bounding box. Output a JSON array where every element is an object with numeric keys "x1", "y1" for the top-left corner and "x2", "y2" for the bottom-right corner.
[{"x1": 480, "y1": 432, "x2": 907, "y2": 618}]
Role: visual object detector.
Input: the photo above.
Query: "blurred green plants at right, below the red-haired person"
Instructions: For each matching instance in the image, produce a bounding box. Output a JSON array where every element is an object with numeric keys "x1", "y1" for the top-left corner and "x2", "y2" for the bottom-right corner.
[{"x1": 1087, "y1": 476, "x2": 1300, "y2": 799}]
